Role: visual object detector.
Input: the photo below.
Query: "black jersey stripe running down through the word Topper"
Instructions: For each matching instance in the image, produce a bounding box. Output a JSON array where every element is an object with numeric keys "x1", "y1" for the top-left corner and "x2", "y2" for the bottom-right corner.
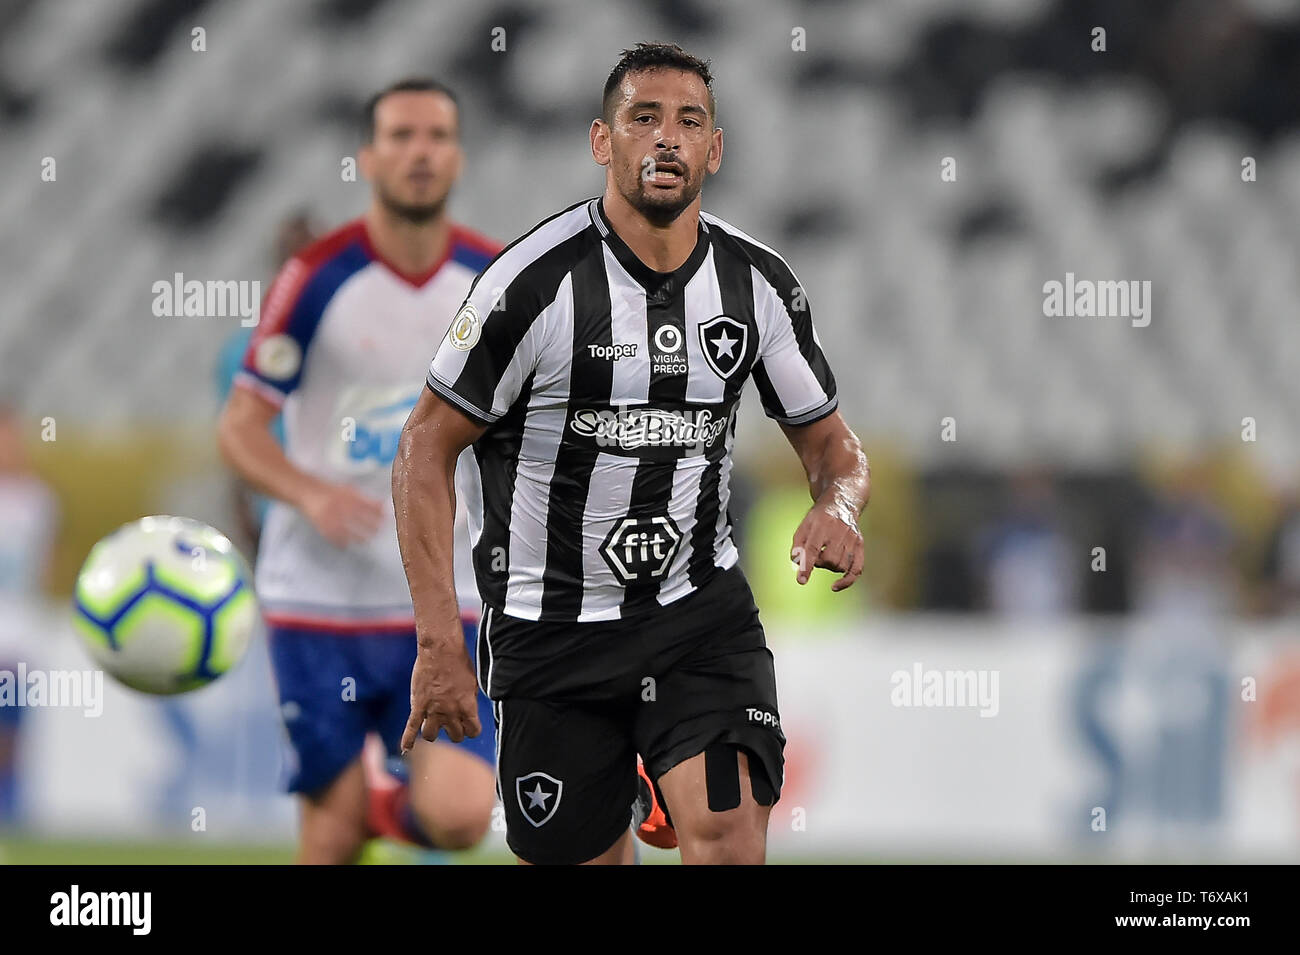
[{"x1": 542, "y1": 229, "x2": 614, "y2": 620}]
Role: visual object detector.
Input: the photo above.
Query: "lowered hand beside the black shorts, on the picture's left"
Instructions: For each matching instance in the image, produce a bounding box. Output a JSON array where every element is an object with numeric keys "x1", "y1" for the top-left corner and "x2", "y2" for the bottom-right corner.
[{"x1": 402, "y1": 630, "x2": 482, "y2": 754}]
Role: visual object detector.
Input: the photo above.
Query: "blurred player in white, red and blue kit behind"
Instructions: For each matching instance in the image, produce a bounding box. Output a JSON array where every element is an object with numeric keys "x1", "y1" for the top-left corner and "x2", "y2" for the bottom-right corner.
[{"x1": 218, "y1": 79, "x2": 499, "y2": 863}]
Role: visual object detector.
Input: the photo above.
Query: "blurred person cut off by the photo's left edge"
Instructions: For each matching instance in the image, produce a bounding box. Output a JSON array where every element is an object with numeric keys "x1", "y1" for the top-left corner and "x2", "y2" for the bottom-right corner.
[{"x1": 0, "y1": 400, "x2": 59, "y2": 828}]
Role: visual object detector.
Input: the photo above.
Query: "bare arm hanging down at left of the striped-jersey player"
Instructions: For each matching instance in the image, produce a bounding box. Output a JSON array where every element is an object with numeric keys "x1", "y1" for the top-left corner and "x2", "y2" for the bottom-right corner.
[{"x1": 393, "y1": 388, "x2": 486, "y2": 752}]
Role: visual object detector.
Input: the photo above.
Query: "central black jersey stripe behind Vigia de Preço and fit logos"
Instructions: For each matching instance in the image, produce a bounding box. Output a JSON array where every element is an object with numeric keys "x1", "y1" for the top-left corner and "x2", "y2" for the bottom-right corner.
[{"x1": 620, "y1": 270, "x2": 696, "y2": 616}]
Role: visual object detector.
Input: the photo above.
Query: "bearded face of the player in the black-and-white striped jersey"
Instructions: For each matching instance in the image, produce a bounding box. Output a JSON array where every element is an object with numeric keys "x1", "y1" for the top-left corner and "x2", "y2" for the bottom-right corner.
[{"x1": 593, "y1": 69, "x2": 723, "y2": 225}]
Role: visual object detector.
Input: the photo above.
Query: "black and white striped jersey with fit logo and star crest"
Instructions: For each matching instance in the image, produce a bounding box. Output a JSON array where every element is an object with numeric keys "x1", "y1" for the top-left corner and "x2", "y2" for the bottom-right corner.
[{"x1": 428, "y1": 199, "x2": 837, "y2": 621}]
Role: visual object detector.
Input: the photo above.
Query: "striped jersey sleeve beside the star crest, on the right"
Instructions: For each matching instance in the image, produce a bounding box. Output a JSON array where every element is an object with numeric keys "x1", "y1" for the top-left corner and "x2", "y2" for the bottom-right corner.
[{"x1": 754, "y1": 264, "x2": 840, "y2": 425}]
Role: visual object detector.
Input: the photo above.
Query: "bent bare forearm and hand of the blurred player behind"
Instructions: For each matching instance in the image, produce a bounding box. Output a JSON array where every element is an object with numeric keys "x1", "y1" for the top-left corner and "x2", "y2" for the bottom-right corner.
[{"x1": 217, "y1": 385, "x2": 384, "y2": 547}]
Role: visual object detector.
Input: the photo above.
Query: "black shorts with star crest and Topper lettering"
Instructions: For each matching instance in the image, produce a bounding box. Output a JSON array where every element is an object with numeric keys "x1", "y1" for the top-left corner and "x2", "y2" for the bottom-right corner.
[{"x1": 477, "y1": 568, "x2": 785, "y2": 864}]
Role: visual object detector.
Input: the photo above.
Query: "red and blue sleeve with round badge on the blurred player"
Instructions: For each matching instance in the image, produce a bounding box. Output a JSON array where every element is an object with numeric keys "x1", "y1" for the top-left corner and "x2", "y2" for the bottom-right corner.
[{"x1": 234, "y1": 257, "x2": 319, "y2": 407}]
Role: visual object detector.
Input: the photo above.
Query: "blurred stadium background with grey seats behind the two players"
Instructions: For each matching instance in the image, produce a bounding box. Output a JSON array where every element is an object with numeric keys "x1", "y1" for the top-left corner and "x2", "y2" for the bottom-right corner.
[{"x1": 0, "y1": 0, "x2": 1300, "y2": 861}]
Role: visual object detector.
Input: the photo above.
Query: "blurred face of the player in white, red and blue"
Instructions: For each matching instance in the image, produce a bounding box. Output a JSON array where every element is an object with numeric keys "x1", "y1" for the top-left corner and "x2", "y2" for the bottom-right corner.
[{"x1": 360, "y1": 91, "x2": 462, "y2": 222}]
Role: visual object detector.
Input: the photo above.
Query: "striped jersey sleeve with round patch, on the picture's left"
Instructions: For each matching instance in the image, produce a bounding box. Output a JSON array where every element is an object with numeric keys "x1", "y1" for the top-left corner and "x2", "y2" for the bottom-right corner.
[{"x1": 425, "y1": 257, "x2": 542, "y2": 427}]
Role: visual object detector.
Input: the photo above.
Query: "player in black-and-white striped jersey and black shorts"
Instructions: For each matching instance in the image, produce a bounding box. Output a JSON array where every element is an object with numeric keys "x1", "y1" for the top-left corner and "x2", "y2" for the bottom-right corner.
[{"x1": 393, "y1": 44, "x2": 868, "y2": 864}]
